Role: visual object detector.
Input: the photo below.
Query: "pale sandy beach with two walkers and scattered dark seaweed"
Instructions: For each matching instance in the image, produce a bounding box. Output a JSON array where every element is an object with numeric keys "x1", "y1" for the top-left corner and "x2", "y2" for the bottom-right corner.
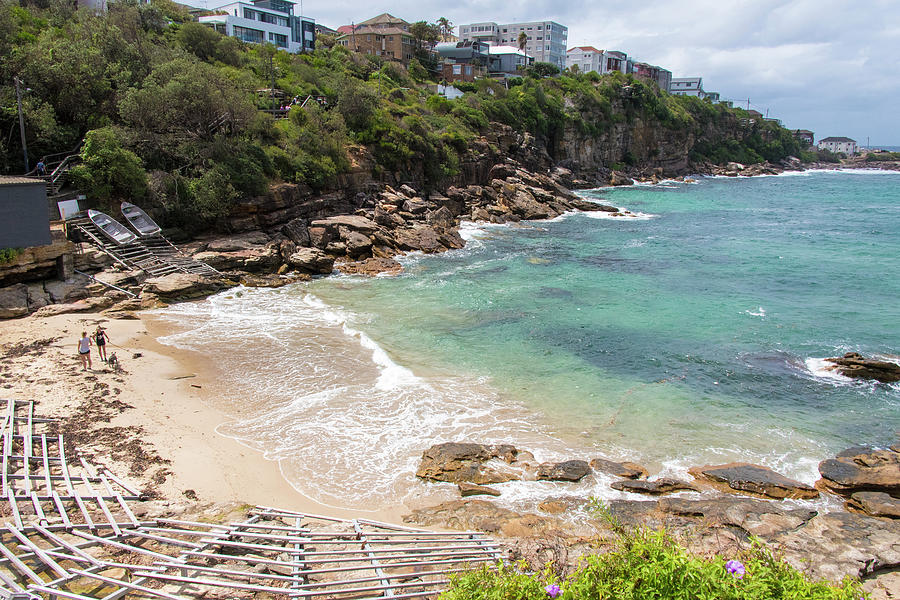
[{"x1": 0, "y1": 313, "x2": 402, "y2": 520}]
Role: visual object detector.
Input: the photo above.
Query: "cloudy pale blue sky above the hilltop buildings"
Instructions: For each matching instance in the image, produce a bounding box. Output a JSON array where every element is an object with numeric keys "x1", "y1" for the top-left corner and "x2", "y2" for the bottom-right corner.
[{"x1": 308, "y1": 0, "x2": 900, "y2": 146}]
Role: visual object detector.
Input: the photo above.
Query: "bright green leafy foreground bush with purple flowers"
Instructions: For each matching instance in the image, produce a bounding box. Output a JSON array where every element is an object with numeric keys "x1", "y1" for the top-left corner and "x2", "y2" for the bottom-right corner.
[{"x1": 441, "y1": 529, "x2": 866, "y2": 600}]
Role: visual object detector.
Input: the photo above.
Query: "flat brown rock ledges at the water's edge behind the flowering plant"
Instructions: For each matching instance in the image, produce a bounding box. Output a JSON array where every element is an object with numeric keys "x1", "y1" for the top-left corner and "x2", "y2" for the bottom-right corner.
[{"x1": 404, "y1": 442, "x2": 900, "y2": 598}]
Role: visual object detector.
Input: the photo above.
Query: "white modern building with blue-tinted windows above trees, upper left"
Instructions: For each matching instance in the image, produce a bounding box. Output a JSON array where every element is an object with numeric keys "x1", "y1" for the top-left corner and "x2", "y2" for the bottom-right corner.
[{"x1": 195, "y1": 0, "x2": 316, "y2": 52}]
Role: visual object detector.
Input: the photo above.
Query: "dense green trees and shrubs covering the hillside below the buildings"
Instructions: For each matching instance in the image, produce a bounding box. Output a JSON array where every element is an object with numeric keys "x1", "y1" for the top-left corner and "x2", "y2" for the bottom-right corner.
[{"x1": 0, "y1": 0, "x2": 802, "y2": 230}]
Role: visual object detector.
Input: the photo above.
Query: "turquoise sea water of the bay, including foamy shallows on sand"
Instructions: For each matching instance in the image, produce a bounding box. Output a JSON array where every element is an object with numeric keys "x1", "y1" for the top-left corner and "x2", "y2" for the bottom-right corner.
[{"x1": 160, "y1": 172, "x2": 900, "y2": 508}]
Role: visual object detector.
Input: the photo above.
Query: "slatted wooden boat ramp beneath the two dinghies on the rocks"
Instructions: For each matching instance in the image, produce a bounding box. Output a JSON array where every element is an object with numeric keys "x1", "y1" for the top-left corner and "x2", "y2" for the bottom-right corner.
[{"x1": 66, "y1": 214, "x2": 222, "y2": 277}]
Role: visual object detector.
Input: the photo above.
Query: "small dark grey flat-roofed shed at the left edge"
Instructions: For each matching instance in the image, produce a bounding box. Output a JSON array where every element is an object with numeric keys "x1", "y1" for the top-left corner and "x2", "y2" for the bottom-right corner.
[{"x1": 0, "y1": 175, "x2": 50, "y2": 248}]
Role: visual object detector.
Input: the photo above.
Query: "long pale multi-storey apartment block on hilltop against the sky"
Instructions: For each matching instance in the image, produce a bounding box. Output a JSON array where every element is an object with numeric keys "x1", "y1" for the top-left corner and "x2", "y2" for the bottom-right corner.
[{"x1": 459, "y1": 21, "x2": 569, "y2": 70}]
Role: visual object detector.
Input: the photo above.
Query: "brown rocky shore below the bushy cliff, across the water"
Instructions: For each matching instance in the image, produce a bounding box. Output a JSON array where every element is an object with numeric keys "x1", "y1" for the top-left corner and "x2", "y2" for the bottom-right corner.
[{"x1": 0, "y1": 152, "x2": 900, "y2": 319}]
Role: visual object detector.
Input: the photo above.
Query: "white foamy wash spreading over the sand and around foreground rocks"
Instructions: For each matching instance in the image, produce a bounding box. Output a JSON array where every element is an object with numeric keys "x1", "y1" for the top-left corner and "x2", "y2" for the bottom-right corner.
[{"x1": 156, "y1": 278, "x2": 864, "y2": 510}]
